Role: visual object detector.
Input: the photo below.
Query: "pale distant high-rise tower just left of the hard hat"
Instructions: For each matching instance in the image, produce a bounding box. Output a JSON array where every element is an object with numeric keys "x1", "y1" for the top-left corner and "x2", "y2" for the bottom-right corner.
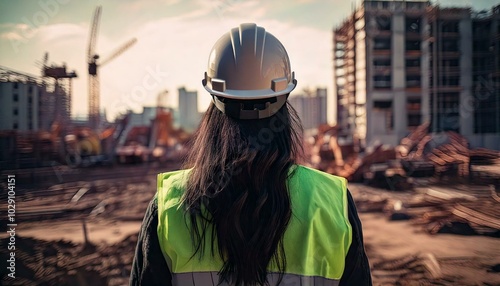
[{"x1": 179, "y1": 87, "x2": 200, "y2": 131}]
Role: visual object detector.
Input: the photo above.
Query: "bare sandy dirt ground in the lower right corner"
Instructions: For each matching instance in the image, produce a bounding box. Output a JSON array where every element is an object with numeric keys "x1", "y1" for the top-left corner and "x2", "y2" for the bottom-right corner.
[{"x1": 360, "y1": 213, "x2": 500, "y2": 285}]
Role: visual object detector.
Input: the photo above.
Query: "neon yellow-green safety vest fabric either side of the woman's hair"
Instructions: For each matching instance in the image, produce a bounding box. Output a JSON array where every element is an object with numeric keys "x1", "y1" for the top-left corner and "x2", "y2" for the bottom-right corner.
[{"x1": 157, "y1": 165, "x2": 352, "y2": 286}]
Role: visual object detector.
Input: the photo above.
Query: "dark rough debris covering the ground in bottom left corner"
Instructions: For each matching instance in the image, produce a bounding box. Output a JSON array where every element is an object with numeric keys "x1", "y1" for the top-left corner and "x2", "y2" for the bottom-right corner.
[{"x1": 0, "y1": 235, "x2": 137, "y2": 286}]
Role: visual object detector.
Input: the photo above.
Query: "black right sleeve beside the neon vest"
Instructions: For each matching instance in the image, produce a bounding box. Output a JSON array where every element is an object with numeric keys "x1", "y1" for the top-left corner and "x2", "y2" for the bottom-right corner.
[{"x1": 340, "y1": 190, "x2": 372, "y2": 286}]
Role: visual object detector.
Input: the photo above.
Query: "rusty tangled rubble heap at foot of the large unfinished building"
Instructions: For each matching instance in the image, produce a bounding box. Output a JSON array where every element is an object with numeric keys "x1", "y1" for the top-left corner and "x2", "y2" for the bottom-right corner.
[{"x1": 310, "y1": 123, "x2": 500, "y2": 190}]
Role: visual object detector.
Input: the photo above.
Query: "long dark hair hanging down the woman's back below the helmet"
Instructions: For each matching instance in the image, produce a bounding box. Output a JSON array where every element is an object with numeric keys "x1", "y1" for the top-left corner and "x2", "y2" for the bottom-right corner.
[{"x1": 183, "y1": 99, "x2": 302, "y2": 285}]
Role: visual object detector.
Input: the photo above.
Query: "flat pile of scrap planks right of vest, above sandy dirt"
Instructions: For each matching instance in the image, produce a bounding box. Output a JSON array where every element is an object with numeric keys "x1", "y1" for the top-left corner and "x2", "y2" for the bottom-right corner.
[{"x1": 355, "y1": 186, "x2": 500, "y2": 237}]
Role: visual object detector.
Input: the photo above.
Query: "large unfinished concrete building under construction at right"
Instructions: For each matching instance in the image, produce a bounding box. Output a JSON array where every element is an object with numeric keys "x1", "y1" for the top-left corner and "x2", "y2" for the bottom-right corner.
[{"x1": 333, "y1": 0, "x2": 500, "y2": 149}]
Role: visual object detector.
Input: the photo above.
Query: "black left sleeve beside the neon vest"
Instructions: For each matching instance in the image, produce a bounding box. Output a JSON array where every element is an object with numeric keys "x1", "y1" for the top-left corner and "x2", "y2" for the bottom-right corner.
[{"x1": 129, "y1": 197, "x2": 172, "y2": 286}]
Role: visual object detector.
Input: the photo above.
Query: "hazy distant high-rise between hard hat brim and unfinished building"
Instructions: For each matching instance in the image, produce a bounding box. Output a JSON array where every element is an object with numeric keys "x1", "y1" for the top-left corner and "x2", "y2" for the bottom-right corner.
[{"x1": 289, "y1": 88, "x2": 327, "y2": 130}]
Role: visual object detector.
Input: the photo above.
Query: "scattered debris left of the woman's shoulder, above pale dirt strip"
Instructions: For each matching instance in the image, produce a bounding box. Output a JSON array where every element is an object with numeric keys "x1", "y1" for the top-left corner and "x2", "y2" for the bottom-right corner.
[{"x1": 0, "y1": 165, "x2": 166, "y2": 229}]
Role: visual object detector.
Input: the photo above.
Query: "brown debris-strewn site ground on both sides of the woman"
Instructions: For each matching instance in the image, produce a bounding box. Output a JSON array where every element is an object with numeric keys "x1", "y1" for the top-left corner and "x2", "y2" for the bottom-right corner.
[{"x1": 0, "y1": 163, "x2": 500, "y2": 286}]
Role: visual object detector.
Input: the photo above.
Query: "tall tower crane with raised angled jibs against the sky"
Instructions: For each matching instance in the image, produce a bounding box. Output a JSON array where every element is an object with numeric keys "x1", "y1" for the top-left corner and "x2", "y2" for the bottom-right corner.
[{"x1": 87, "y1": 6, "x2": 137, "y2": 130}]
